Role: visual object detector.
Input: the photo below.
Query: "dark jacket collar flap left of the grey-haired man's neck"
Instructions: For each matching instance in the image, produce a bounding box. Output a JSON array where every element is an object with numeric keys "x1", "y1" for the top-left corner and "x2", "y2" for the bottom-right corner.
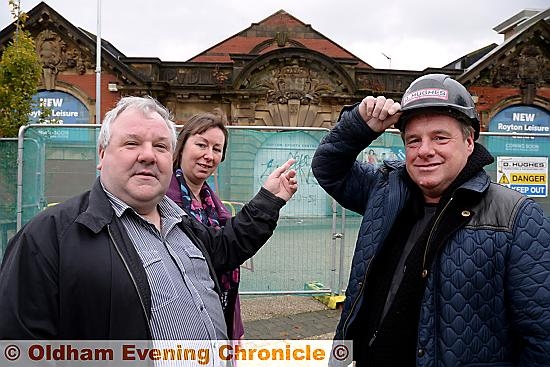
[{"x1": 76, "y1": 177, "x2": 115, "y2": 233}]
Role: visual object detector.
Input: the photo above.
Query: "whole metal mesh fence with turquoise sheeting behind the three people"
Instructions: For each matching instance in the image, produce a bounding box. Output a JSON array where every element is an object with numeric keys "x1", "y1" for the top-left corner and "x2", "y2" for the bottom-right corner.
[{"x1": 0, "y1": 125, "x2": 550, "y2": 294}]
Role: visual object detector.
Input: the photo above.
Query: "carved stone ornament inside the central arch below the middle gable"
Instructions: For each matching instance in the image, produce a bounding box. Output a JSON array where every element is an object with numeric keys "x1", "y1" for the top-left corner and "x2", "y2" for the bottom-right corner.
[{"x1": 248, "y1": 61, "x2": 341, "y2": 105}]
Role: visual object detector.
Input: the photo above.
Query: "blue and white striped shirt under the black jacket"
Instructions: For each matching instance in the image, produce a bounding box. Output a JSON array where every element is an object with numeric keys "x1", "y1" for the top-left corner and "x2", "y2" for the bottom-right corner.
[{"x1": 103, "y1": 188, "x2": 227, "y2": 340}]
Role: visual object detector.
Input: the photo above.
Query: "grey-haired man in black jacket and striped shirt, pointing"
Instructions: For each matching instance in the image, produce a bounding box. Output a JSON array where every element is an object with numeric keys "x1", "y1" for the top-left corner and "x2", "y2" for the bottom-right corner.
[{"x1": 0, "y1": 97, "x2": 297, "y2": 340}]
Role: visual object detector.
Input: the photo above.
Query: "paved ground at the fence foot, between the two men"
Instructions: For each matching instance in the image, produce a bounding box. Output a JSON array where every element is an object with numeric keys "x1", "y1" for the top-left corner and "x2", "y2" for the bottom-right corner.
[{"x1": 241, "y1": 296, "x2": 340, "y2": 340}]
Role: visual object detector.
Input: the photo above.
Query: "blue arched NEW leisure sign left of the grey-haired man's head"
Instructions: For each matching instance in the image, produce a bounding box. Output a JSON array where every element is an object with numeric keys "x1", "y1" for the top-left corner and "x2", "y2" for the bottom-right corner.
[{"x1": 29, "y1": 91, "x2": 90, "y2": 141}]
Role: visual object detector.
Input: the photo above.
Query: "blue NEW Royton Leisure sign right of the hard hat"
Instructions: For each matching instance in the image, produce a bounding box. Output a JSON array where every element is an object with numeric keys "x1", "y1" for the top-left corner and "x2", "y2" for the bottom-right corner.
[{"x1": 487, "y1": 106, "x2": 550, "y2": 156}]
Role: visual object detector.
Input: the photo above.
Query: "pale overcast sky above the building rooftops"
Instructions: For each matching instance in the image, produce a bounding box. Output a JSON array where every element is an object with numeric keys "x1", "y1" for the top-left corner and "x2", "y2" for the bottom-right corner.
[{"x1": 0, "y1": 0, "x2": 550, "y2": 70}]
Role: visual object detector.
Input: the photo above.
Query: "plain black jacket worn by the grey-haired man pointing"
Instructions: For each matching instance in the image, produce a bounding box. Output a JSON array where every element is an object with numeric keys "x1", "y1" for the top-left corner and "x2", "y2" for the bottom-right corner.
[{"x1": 0, "y1": 179, "x2": 285, "y2": 339}]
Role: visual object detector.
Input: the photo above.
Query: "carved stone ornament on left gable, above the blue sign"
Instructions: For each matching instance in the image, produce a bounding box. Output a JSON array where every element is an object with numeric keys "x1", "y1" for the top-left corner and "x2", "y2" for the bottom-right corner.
[{"x1": 36, "y1": 29, "x2": 92, "y2": 89}]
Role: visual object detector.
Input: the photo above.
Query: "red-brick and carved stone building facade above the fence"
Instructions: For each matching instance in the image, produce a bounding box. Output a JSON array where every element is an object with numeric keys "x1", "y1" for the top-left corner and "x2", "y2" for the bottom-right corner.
[{"x1": 0, "y1": 2, "x2": 550, "y2": 129}]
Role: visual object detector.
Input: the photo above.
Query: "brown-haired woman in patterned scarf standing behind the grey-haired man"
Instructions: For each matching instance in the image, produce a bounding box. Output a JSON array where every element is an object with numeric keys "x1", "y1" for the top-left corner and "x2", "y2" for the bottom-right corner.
[{"x1": 166, "y1": 108, "x2": 244, "y2": 340}]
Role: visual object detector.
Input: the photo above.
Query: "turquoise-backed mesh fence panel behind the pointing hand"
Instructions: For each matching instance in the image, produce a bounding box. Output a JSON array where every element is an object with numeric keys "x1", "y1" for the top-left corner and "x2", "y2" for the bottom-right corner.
[{"x1": 217, "y1": 128, "x2": 335, "y2": 292}]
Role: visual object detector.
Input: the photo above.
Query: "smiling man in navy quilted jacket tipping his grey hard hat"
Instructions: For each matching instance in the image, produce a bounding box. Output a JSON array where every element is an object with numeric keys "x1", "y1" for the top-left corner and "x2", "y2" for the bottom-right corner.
[{"x1": 312, "y1": 74, "x2": 550, "y2": 367}]
